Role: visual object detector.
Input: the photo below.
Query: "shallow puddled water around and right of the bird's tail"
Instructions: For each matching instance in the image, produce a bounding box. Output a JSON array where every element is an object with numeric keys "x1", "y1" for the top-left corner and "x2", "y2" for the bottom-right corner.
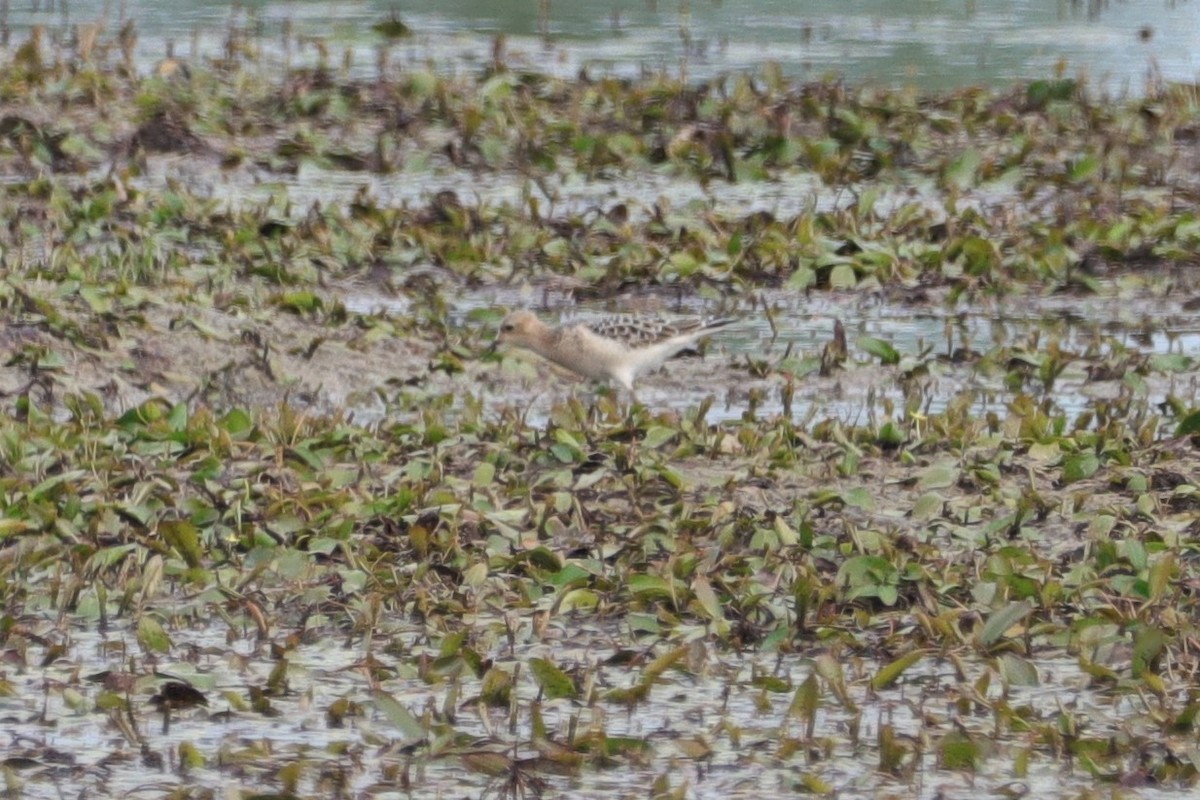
[{"x1": 343, "y1": 288, "x2": 1200, "y2": 425}]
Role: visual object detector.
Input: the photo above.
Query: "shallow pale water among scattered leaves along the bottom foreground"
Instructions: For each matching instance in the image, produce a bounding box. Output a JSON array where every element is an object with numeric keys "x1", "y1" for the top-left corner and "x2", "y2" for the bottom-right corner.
[{"x1": 9, "y1": 608, "x2": 1177, "y2": 800}]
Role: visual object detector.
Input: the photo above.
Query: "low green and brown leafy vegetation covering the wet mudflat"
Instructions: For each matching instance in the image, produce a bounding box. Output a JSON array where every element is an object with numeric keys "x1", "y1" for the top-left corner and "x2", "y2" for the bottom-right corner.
[{"x1": 0, "y1": 21, "x2": 1200, "y2": 798}]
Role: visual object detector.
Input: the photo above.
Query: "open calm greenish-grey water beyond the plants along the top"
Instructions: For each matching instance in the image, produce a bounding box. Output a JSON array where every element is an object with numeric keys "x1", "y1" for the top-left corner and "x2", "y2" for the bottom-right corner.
[{"x1": 0, "y1": 0, "x2": 1200, "y2": 94}]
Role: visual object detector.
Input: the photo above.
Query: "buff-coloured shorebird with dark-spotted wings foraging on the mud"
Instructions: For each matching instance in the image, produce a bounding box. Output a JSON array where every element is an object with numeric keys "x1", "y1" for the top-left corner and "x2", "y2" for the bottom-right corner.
[{"x1": 492, "y1": 309, "x2": 737, "y2": 393}]
